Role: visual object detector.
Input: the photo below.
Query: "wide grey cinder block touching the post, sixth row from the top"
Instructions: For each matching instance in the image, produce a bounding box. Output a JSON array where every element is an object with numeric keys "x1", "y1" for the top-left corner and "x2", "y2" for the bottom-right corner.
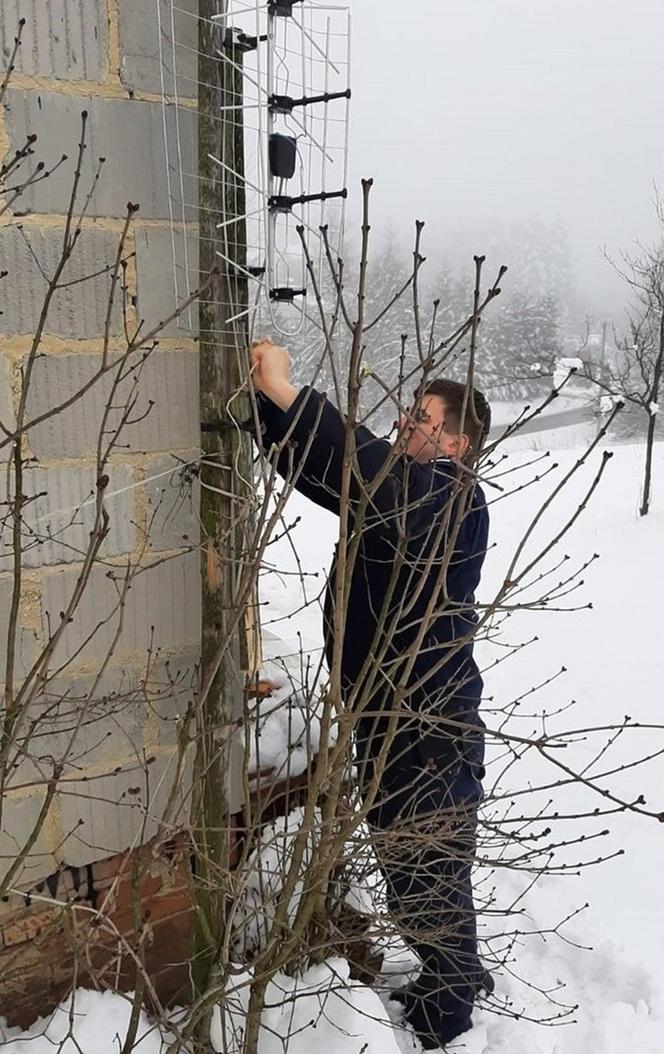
[{"x1": 42, "y1": 552, "x2": 200, "y2": 663}]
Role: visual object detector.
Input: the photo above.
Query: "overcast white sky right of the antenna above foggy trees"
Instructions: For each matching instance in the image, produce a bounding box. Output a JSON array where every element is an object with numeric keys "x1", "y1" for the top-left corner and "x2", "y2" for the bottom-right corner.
[{"x1": 350, "y1": 0, "x2": 664, "y2": 313}]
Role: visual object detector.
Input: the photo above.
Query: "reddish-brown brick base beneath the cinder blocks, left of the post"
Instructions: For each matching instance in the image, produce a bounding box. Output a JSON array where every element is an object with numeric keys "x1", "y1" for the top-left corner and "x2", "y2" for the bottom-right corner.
[{"x1": 0, "y1": 837, "x2": 192, "y2": 1028}]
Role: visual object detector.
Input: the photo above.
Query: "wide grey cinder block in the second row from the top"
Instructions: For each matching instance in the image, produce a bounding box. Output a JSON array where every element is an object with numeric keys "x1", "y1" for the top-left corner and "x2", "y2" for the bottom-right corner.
[{"x1": 6, "y1": 90, "x2": 196, "y2": 219}]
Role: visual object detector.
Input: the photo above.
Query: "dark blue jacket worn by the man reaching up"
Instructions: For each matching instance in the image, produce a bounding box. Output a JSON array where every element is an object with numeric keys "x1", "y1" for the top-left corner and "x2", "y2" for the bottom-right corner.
[{"x1": 259, "y1": 388, "x2": 489, "y2": 775}]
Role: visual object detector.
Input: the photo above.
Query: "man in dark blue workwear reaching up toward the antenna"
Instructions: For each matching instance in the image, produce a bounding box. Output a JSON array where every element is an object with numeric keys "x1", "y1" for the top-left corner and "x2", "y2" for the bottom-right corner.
[{"x1": 251, "y1": 340, "x2": 490, "y2": 1049}]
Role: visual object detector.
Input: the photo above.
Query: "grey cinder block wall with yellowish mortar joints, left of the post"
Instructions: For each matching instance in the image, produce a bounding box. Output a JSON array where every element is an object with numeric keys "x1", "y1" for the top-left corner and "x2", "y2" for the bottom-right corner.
[{"x1": 0, "y1": 0, "x2": 200, "y2": 898}]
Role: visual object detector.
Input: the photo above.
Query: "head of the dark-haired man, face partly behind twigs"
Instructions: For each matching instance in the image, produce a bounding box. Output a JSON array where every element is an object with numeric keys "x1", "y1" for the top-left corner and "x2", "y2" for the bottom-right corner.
[{"x1": 398, "y1": 378, "x2": 491, "y2": 462}]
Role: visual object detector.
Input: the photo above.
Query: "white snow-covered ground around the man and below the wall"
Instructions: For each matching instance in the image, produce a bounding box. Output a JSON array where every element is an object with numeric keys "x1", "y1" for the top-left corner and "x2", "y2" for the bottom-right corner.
[{"x1": 1, "y1": 437, "x2": 664, "y2": 1054}]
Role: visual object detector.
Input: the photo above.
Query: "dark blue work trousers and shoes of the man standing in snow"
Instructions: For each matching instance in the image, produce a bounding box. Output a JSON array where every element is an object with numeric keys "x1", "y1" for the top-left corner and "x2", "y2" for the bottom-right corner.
[{"x1": 360, "y1": 729, "x2": 483, "y2": 1047}]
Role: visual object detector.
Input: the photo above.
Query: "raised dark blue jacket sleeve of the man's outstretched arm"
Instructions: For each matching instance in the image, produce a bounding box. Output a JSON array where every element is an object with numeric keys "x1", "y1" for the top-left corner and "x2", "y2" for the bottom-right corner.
[{"x1": 254, "y1": 388, "x2": 453, "y2": 534}]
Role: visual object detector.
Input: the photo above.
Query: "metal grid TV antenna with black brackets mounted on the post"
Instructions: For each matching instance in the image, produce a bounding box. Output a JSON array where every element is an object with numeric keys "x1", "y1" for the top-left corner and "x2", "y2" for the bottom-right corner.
[{"x1": 155, "y1": 0, "x2": 351, "y2": 338}]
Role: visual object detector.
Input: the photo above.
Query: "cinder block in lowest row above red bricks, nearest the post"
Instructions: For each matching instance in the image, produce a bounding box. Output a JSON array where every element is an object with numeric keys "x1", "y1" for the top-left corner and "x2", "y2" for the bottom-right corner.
[{"x1": 58, "y1": 754, "x2": 189, "y2": 867}]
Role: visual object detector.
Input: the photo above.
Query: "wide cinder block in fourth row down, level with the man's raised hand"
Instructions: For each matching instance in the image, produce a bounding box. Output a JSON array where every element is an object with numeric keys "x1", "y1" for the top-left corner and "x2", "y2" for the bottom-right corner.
[{"x1": 27, "y1": 350, "x2": 200, "y2": 457}]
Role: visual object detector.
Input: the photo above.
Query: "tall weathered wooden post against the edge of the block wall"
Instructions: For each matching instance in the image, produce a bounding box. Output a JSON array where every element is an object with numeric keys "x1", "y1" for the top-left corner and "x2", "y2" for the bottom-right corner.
[{"x1": 192, "y1": 0, "x2": 251, "y2": 1003}]
